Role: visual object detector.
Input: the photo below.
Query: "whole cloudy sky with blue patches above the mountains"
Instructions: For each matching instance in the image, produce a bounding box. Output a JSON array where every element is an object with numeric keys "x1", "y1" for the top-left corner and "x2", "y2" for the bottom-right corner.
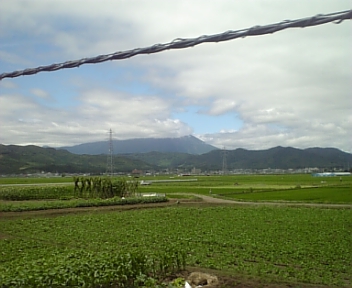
[{"x1": 0, "y1": 0, "x2": 352, "y2": 152}]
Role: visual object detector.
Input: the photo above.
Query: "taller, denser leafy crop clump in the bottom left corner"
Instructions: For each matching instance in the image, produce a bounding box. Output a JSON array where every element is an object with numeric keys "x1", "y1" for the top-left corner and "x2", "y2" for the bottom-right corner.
[{"x1": 0, "y1": 249, "x2": 186, "y2": 288}]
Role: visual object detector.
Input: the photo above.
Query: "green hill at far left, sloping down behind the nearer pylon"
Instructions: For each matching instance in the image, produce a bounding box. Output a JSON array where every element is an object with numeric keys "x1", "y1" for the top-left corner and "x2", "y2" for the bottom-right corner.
[{"x1": 0, "y1": 144, "x2": 157, "y2": 174}]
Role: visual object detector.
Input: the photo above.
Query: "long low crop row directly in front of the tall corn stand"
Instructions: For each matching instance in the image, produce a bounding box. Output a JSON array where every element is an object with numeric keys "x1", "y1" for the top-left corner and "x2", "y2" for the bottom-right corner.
[{"x1": 0, "y1": 197, "x2": 168, "y2": 212}]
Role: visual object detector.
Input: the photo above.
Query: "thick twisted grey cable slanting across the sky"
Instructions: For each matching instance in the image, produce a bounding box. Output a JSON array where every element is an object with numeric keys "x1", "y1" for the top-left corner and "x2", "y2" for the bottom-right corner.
[{"x1": 0, "y1": 10, "x2": 352, "y2": 80}]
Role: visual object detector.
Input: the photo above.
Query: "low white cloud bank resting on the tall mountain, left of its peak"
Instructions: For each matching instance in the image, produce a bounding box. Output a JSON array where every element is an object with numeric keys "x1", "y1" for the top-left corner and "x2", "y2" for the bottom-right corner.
[{"x1": 0, "y1": 90, "x2": 193, "y2": 147}]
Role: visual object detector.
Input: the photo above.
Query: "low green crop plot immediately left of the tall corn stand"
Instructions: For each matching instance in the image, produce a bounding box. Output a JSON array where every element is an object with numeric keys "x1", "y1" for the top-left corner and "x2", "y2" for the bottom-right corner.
[{"x1": 0, "y1": 185, "x2": 74, "y2": 201}]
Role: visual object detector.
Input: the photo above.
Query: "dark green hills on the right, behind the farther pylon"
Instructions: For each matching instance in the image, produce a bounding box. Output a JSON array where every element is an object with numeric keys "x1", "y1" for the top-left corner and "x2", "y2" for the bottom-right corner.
[{"x1": 125, "y1": 146, "x2": 352, "y2": 171}]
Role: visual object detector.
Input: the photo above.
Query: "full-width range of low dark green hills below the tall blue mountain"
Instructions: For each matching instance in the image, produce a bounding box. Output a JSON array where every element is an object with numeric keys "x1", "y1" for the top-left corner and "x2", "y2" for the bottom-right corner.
[{"x1": 0, "y1": 138, "x2": 352, "y2": 174}]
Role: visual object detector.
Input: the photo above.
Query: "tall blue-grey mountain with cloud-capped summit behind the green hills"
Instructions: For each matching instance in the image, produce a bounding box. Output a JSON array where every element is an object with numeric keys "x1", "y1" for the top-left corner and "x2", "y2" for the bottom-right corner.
[{"x1": 59, "y1": 135, "x2": 218, "y2": 155}]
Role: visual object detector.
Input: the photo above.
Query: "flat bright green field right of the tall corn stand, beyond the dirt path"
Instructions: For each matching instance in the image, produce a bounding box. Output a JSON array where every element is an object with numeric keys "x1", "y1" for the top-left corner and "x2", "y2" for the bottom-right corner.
[{"x1": 139, "y1": 174, "x2": 352, "y2": 203}]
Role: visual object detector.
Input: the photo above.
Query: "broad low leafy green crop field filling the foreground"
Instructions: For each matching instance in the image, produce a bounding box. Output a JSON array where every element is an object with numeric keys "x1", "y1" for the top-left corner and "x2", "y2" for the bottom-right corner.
[{"x1": 0, "y1": 206, "x2": 352, "y2": 287}]
